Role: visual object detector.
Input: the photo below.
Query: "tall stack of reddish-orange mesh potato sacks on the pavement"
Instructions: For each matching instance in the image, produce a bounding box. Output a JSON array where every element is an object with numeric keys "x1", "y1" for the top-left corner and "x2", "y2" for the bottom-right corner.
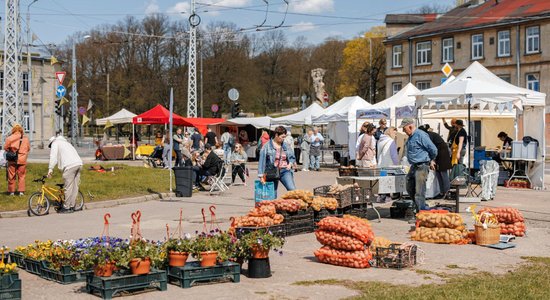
[{"x1": 314, "y1": 215, "x2": 374, "y2": 268}]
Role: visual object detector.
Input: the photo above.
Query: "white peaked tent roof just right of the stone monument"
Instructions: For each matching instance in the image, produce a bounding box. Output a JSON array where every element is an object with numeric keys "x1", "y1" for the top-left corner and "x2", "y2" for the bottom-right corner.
[{"x1": 311, "y1": 96, "x2": 372, "y2": 124}]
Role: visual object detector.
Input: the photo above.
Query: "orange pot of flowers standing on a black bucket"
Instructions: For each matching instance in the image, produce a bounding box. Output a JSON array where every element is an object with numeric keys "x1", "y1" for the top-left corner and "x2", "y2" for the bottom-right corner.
[{"x1": 239, "y1": 230, "x2": 285, "y2": 258}]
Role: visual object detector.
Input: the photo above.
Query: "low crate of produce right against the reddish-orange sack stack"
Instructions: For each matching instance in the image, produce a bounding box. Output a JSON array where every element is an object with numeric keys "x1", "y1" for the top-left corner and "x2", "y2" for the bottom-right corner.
[{"x1": 375, "y1": 244, "x2": 417, "y2": 269}]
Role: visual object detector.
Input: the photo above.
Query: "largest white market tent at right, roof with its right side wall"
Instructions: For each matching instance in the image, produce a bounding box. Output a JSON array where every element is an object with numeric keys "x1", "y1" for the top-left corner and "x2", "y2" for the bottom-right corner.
[{"x1": 416, "y1": 62, "x2": 546, "y2": 188}]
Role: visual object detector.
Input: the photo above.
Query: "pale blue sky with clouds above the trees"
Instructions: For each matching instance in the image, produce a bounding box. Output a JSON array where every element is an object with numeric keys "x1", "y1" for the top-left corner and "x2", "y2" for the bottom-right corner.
[{"x1": 17, "y1": 0, "x2": 454, "y2": 44}]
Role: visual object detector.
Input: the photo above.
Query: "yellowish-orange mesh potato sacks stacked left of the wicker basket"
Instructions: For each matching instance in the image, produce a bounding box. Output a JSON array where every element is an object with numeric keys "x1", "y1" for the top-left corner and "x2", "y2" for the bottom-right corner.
[{"x1": 411, "y1": 211, "x2": 468, "y2": 244}]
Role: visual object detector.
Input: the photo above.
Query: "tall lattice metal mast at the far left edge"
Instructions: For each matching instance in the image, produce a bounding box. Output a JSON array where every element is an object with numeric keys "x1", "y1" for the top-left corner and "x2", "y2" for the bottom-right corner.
[{"x1": 1, "y1": 0, "x2": 23, "y2": 145}]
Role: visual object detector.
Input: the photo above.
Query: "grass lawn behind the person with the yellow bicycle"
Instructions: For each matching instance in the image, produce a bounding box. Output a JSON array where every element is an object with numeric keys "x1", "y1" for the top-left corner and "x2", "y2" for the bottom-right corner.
[{"x1": 0, "y1": 163, "x2": 170, "y2": 211}]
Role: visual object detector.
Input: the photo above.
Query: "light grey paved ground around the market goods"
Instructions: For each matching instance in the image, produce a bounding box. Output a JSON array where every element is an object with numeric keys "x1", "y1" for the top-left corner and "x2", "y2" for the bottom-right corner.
[{"x1": 0, "y1": 150, "x2": 550, "y2": 299}]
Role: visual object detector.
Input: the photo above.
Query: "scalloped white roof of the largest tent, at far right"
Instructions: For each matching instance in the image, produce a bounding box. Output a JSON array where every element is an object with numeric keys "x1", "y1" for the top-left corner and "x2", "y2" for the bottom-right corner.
[{"x1": 416, "y1": 62, "x2": 546, "y2": 111}]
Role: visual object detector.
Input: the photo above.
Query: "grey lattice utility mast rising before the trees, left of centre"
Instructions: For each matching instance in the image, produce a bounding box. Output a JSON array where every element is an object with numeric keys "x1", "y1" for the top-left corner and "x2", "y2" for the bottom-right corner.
[{"x1": 187, "y1": 0, "x2": 201, "y2": 118}]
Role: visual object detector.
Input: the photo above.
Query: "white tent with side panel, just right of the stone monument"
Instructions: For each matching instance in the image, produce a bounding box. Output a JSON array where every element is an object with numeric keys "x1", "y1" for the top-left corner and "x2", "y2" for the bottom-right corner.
[{"x1": 311, "y1": 96, "x2": 372, "y2": 159}]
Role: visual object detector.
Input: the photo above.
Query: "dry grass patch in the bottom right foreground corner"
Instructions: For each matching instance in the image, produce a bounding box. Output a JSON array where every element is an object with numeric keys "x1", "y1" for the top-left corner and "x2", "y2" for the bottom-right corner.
[{"x1": 296, "y1": 257, "x2": 550, "y2": 299}]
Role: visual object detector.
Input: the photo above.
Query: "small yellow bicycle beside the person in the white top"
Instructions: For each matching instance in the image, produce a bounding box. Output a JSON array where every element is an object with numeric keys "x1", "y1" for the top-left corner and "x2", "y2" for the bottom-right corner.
[{"x1": 27, "y1": 176, "x2": 84, "y2": 216}]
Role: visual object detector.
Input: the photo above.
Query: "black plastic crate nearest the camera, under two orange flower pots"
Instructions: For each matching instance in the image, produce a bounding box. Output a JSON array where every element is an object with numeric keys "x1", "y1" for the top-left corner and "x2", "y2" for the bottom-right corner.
[{"x1": 86, "y1": 268, "x2": 167, "y2": 299}]
